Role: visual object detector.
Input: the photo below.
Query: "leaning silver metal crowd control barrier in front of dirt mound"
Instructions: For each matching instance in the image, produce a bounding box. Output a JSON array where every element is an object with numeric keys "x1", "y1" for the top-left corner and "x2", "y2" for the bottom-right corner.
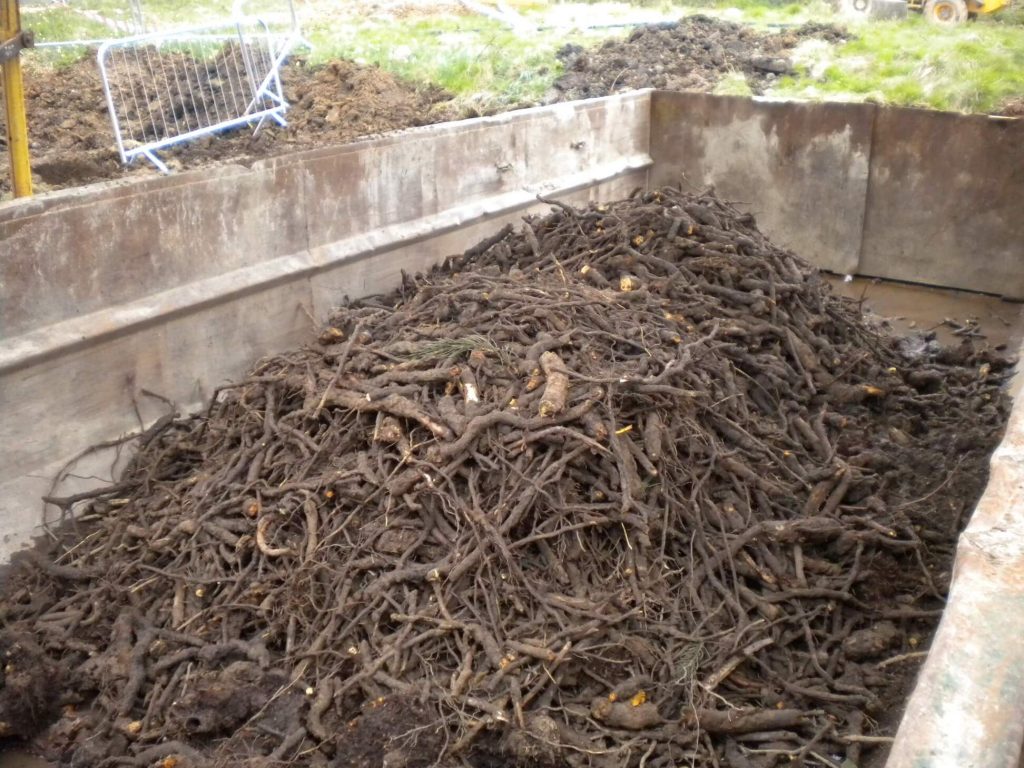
[{"x1": 97, "y1": 18, "x2": 291, "y2": 173}]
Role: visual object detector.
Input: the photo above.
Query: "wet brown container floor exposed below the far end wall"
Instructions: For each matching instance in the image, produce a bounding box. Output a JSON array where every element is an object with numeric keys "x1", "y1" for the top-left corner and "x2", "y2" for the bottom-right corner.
[{"x1": 0, "y1": 275, "x2": 1024, "y2": 768}]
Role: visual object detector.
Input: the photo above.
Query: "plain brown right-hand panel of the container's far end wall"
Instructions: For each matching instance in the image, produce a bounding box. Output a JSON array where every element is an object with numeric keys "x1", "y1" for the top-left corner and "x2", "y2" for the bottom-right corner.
[{"x1": 858, "y1": 110, "x2": 1024, "y2": 299}]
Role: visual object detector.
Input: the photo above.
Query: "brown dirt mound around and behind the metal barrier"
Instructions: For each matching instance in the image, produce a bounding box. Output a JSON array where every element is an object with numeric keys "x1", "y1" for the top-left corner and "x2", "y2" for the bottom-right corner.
[{"x1": 0, "y1": 54, "x2": 450, "y2": 190}]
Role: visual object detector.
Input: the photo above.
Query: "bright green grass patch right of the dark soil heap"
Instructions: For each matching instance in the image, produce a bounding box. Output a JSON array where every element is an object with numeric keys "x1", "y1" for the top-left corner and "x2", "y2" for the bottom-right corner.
[{"x1": 774, "y1": 15, "x2": 1024, "y2": 112}]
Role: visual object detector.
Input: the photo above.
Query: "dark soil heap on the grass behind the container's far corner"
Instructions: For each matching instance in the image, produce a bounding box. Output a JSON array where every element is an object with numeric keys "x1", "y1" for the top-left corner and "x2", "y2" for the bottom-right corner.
[{"x1": 552, "y1": 15, "x2": 847, "y2": 100}]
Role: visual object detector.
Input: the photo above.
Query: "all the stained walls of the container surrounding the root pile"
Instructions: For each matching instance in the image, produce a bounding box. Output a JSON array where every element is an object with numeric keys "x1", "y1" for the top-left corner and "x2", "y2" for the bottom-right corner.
[{"x1": 6, "y1": 91, "x2": 1024, "y2": 768}]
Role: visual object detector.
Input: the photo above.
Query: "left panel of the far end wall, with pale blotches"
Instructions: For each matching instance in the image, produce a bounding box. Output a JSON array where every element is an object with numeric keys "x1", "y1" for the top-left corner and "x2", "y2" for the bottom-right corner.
[{"x1": 650, "y1": 92, "x2": 874, "y2": 273}]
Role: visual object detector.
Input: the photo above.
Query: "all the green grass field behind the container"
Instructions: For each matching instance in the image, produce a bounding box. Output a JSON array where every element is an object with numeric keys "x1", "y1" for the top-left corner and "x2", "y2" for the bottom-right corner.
[{"x1": 25, "y1": 0, "x2": 1024, "y2": 112}]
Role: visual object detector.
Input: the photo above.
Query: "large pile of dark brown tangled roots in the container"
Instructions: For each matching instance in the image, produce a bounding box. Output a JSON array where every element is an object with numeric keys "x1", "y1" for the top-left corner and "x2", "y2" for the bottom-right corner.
[{"x1": 0, "y1": 189, "x2": 1009, "y2": 768}]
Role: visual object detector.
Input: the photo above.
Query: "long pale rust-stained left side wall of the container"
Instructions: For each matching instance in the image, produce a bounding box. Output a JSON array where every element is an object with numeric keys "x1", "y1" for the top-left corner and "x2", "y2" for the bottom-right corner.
[{"x1": 0, "y1": 93, "x2": 650, "y2": 560}]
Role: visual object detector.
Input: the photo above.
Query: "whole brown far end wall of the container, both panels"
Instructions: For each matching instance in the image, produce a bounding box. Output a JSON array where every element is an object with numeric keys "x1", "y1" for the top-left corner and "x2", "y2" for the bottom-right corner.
[{"x1": 650, "y1": 92, "x2": 1024, "y2": 299}]
